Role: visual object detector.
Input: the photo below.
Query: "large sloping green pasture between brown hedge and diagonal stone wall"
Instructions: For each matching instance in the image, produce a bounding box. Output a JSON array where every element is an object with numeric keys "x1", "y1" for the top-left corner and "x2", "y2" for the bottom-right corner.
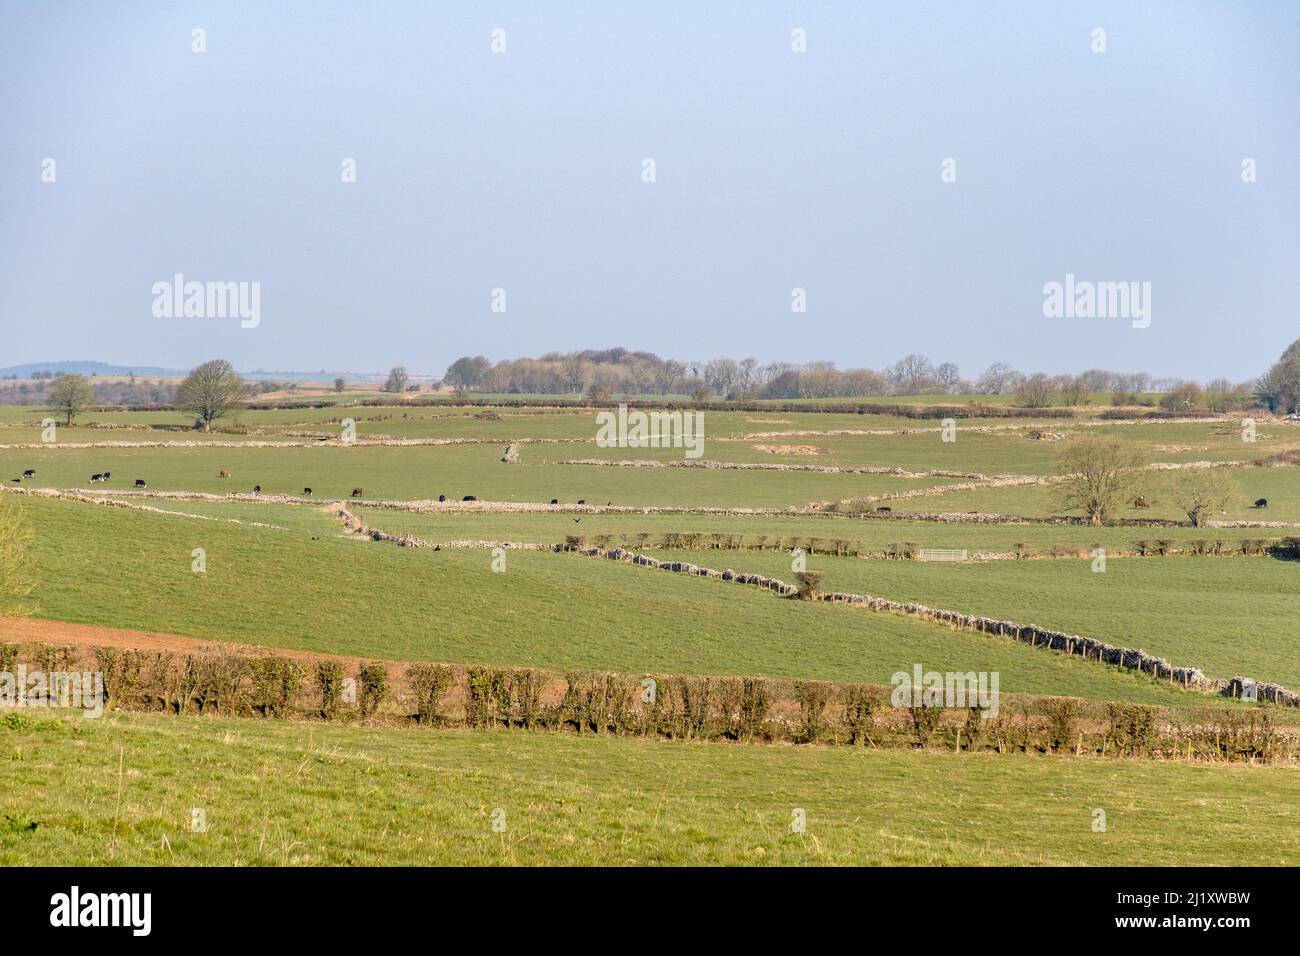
[{"x1": 5, "y1": 498, "x2": 1204, "y2": 705}]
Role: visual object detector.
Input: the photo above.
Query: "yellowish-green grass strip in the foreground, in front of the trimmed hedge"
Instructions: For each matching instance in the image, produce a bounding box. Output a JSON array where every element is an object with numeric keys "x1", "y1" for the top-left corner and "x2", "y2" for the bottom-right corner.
[{"x1": 0, "y1": 714, "x2": 1300, "y2": 866}]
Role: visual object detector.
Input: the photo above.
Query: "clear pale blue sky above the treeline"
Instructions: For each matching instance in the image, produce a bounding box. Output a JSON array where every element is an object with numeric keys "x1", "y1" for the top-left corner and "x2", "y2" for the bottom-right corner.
[{"x1": 0, "y1": 0, "x2": 1300, "y2": 380}]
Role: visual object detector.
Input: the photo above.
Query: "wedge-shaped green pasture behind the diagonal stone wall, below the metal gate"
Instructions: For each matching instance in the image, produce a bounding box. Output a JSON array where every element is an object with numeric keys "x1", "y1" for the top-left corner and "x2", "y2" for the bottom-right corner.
[{"x1": 644, "y1": 551, "x2": 1300, "y2": 689}]
